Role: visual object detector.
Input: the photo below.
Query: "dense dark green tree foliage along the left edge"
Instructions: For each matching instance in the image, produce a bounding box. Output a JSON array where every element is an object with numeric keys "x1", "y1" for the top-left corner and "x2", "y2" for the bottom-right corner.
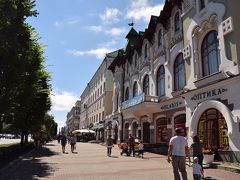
[{"x1": 0, "y1": 0, "x2": 56, "y2": 143}]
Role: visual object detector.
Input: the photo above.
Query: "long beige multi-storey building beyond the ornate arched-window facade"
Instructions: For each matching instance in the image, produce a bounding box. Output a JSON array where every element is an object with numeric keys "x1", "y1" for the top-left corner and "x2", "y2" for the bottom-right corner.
[{"x1": 79, "y1": 51, "x2": 117, "y2": 139}]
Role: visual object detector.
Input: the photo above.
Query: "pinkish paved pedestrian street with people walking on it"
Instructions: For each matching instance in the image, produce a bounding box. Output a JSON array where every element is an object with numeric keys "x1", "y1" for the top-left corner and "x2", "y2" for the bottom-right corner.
[{"x1": 0, "y1": 141, "x2": 240, "y2": 180}]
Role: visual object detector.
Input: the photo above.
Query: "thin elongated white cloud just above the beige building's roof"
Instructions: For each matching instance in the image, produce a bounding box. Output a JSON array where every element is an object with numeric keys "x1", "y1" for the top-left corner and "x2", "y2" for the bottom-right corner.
[{"x1": 68, "y1": 47, "x2": 113, "y2": 59}]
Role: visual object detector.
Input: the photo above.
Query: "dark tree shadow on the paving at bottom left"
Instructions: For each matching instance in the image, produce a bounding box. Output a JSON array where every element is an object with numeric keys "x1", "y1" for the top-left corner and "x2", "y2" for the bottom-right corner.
[{"x1": 0, "y1": 147, "x2": 59, "y2": 180}]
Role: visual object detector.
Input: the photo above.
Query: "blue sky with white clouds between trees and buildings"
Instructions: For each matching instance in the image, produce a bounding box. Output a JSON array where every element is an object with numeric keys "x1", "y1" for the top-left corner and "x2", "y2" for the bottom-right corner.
[{"x1": 27, "y1": 0, "x2": 165, "y2": 128}]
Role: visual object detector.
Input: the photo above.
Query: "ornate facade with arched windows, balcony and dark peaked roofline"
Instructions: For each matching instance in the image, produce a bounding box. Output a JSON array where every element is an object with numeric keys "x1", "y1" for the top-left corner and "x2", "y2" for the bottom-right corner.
[{"x1": 105, "y1": 0, "x2": 240, "y2": 158}]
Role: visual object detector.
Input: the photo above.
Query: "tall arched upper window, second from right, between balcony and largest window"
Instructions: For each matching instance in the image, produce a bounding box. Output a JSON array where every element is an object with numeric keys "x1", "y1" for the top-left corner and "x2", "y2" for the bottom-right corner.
[{"x1": 174, "y1": 54, "x2": 185, "y2": 91}]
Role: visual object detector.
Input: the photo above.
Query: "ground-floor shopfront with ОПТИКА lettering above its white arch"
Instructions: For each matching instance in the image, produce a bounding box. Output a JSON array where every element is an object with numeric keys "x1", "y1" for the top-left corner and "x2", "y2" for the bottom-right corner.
[{"x1": 187, "y1": 76, "x2": 240, "y2": 162}]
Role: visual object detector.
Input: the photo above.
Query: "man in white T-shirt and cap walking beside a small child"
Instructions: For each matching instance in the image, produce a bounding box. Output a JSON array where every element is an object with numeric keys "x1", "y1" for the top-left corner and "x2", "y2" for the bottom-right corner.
[{"x1": 168, "y1": 128, "x2": 190, "y2": 180}]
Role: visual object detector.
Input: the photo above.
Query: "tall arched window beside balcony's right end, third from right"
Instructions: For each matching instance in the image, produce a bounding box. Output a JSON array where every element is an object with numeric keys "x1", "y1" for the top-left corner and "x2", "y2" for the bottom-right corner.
[{"x1": 157, "y1": 65, "x2": 165, "y2": 96}]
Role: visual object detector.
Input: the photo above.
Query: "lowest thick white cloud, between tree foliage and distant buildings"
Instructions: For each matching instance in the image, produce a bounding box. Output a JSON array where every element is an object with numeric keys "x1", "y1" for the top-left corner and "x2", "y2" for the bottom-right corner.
[{"x1": 51, "y1": 91, "x2": 78, "y2": 111}]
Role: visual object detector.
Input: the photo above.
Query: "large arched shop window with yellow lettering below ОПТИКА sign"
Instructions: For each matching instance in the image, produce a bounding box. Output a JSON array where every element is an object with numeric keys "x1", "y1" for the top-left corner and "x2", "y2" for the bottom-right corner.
[{"x1": 198, "y1": 109, "x2": 229, "y2": 150}]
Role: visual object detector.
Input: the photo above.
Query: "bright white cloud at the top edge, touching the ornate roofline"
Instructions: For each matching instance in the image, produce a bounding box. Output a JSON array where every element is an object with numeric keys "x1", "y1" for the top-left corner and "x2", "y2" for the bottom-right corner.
[{"x1": 126, "y1": 0, "x2": 163, "y2": 22}]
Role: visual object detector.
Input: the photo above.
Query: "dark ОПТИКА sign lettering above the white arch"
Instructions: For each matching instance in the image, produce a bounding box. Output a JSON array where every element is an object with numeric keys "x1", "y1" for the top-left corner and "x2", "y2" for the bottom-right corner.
[{"x1": 191, "y1": 88, "x2": 227, "y2": 101}]
